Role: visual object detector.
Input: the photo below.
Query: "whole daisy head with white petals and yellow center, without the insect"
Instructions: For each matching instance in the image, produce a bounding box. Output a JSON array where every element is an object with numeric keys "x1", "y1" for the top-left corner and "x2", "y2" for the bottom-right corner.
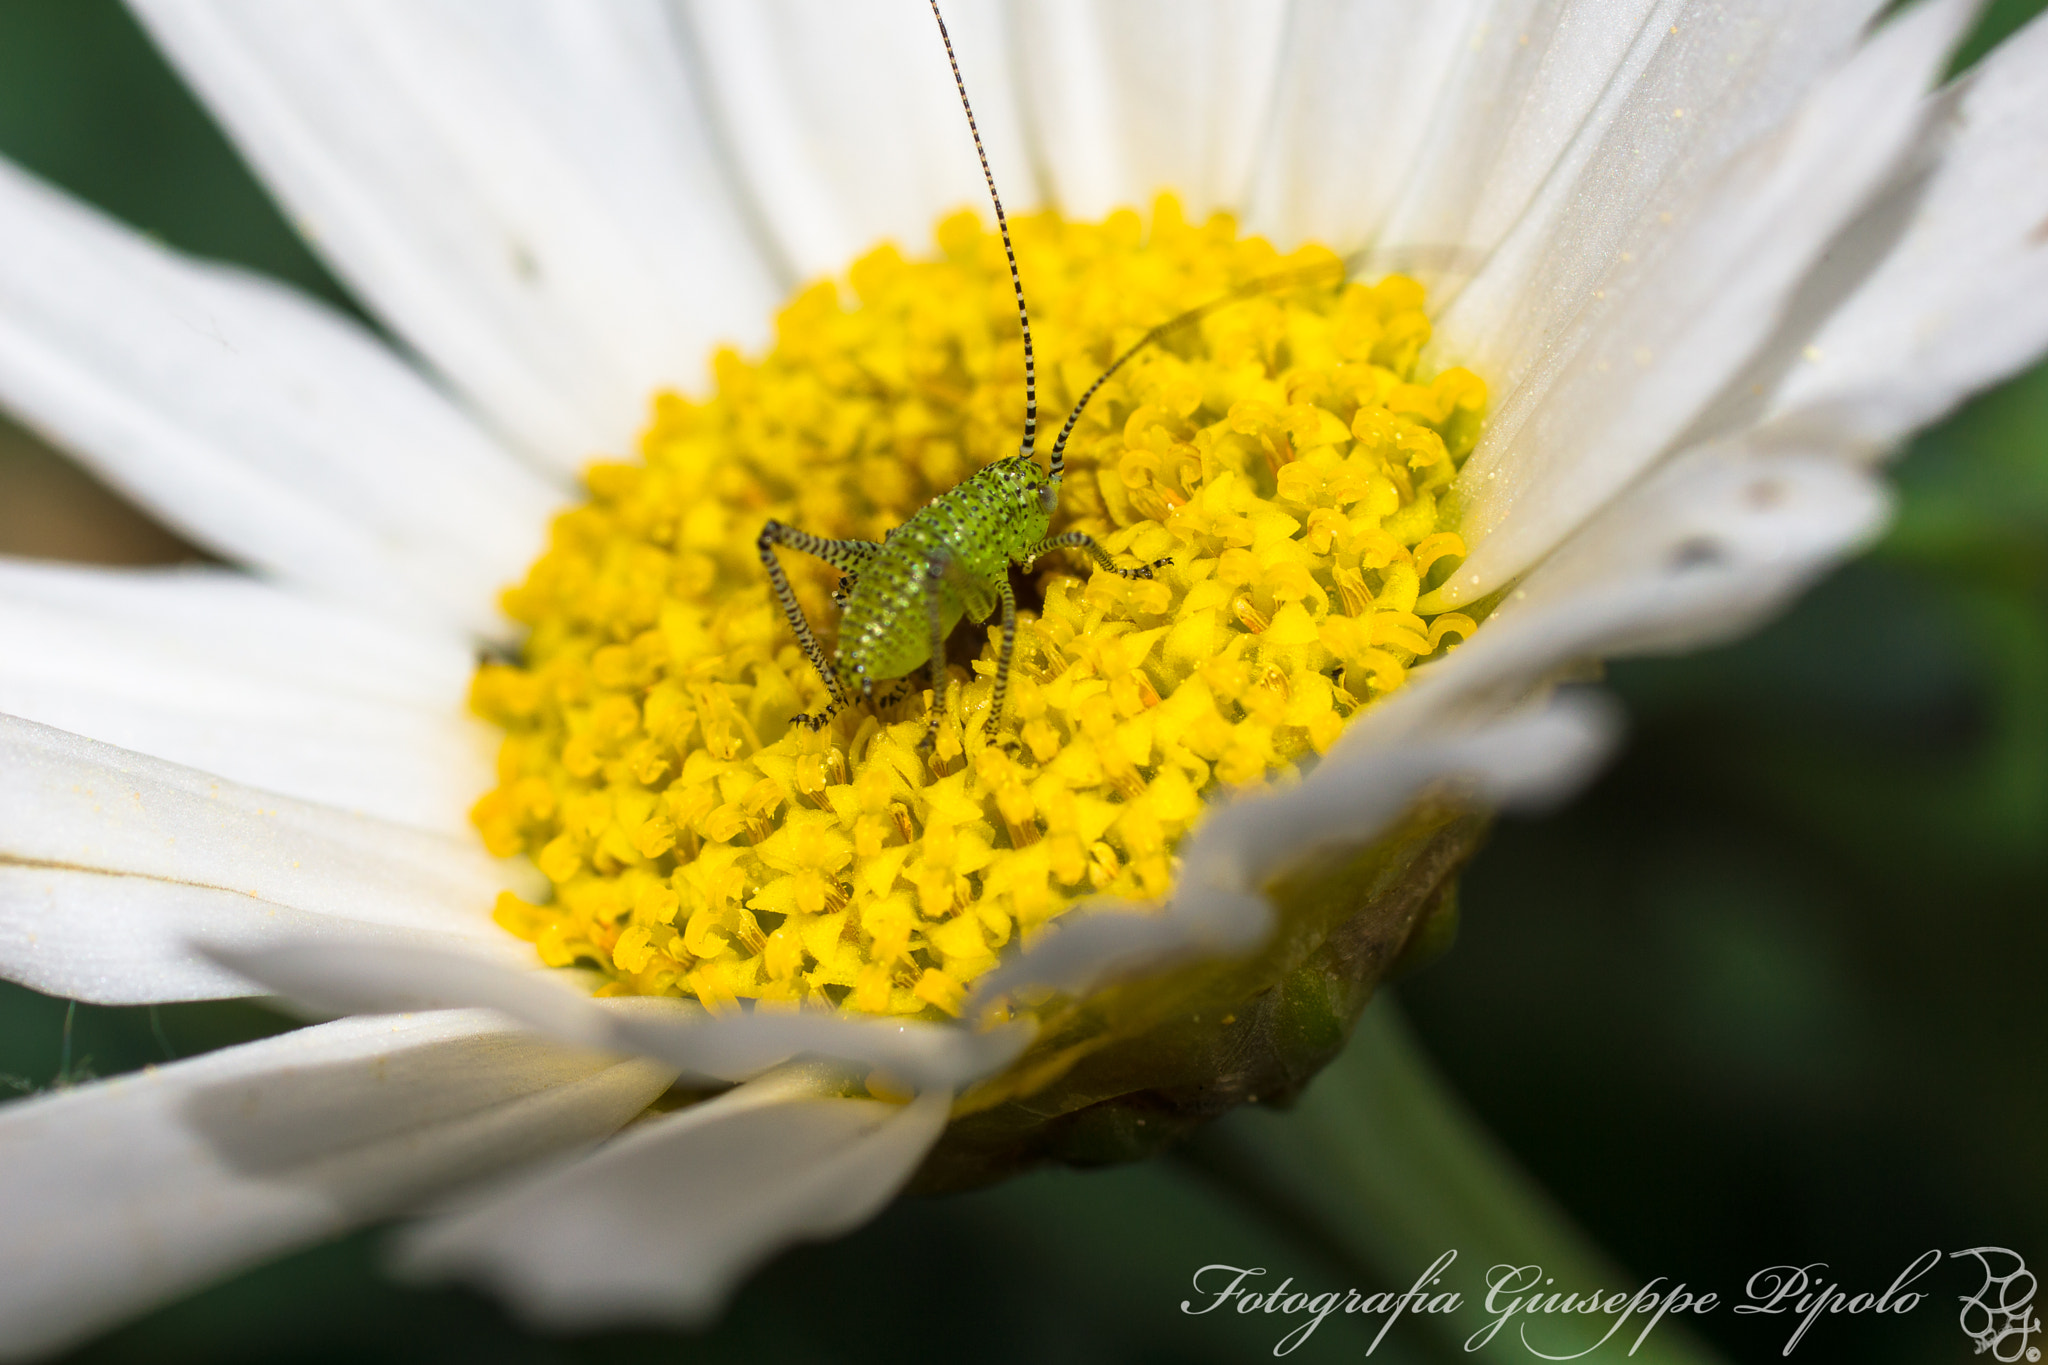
[{"x1": 0, "y1": 0, "x2": 2048, "y2": 1355}]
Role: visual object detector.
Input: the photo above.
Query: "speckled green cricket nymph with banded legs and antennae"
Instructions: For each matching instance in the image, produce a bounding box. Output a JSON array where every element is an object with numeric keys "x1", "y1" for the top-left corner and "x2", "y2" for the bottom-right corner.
[{"x1": 758, "y1": 0, "x2": 1169, "y2": 749}]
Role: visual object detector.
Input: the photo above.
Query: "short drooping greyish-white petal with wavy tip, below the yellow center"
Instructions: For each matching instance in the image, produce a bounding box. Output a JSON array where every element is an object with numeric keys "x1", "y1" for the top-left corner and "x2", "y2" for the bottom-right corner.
[{"x1": 403, "y1": 1072, "x2": 950, "y2": 1328}]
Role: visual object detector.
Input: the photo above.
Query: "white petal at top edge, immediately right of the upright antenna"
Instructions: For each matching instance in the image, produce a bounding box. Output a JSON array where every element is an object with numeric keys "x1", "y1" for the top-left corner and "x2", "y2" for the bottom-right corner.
[{"x1": 1014, "y1": 0, "x2": 1288, "y2": 217}]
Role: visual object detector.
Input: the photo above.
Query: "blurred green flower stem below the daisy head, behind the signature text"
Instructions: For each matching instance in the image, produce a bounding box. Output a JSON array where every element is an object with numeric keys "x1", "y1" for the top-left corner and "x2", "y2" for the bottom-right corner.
[{"x1": 1184, "y1": 997, "x2": 1716, "y2": 1365}]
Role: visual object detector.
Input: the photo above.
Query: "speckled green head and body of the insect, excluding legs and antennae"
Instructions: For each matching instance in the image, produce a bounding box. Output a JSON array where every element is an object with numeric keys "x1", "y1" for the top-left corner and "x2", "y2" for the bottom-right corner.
[{"x1": 836, "y1": 456, "x2": 1053, "y2": 690}]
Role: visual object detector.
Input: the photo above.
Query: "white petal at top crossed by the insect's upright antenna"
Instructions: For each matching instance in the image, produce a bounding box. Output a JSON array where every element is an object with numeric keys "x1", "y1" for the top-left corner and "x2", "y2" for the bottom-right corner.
[{"x1": 682, "y1": 0, "x2": 1038, "y2": 276}]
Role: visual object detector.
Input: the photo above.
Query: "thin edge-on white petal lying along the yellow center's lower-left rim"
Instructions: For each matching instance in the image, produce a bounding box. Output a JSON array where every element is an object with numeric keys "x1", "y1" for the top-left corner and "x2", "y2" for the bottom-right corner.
[{"x1": 213, "y1": 937, "x2": 1030, "y2": 1089}]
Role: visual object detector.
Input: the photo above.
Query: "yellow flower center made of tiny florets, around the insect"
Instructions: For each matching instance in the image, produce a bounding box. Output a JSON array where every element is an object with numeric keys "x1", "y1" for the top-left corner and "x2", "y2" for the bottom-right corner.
[{"x1": 471, "y1": 199, "x2": 1485, "y2": 1017}]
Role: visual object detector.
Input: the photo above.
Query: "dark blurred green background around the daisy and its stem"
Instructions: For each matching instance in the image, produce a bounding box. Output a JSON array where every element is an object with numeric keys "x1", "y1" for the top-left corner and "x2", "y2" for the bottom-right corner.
[{"x1": 0, "y1": 0, "x2": 2048, "y2": 1363}]
